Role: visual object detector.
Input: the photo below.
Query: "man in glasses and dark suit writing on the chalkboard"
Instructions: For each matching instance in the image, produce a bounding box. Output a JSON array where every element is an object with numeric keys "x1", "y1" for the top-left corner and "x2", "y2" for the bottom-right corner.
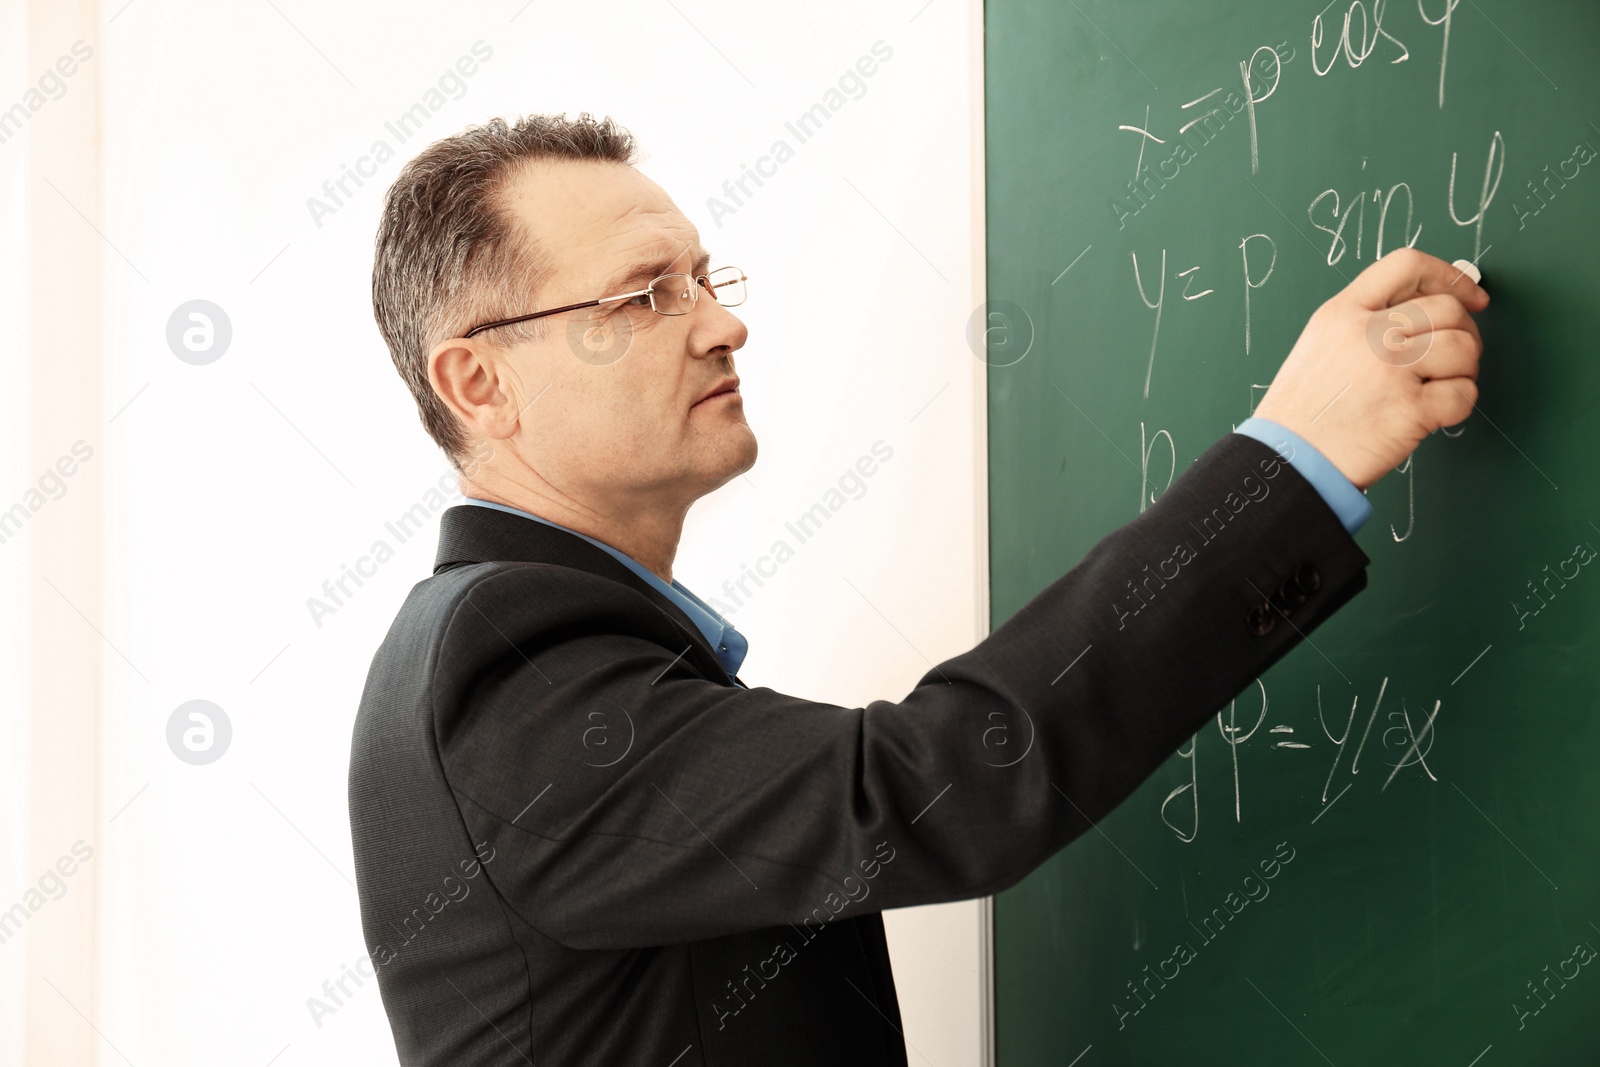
[{"x1": 350, "y1": 106, "x2": 1488, "y2": 1067}]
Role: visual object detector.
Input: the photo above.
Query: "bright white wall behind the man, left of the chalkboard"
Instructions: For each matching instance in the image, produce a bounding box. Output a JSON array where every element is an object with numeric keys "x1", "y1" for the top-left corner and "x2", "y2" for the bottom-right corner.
[{"x1": 18, "y1": 0, "x2": 987, "y2": 1067}]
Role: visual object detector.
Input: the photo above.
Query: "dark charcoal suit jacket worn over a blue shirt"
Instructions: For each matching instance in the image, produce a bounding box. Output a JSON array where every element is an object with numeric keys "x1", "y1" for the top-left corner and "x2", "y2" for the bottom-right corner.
[{"x1": 350, "y1": 434, "x2": 1368, "y2": 1067}]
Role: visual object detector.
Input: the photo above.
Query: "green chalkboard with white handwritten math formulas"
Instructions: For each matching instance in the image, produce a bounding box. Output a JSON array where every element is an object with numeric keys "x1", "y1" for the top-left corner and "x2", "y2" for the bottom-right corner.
[{"x1": 986, "y1": 0, "x2": 1600, "y2": 1067}]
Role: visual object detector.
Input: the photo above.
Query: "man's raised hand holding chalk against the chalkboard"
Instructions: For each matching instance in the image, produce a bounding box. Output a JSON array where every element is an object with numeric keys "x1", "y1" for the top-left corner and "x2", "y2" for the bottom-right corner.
[{"x1": 1256, "y1": 248, "x2": 1490, "y2": 490}]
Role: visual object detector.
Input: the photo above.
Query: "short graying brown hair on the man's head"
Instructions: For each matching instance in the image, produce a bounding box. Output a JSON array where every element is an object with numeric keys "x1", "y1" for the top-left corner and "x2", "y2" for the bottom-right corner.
[{"x1": 373, "y1": 112, "x2": 638, "y2": 470}]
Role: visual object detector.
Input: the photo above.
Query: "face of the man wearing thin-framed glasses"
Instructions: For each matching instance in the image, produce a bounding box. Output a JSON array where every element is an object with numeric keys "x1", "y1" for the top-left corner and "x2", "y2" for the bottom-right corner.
[{"x1": 451, "y1": 160, "x2": 757, "y2": 512}]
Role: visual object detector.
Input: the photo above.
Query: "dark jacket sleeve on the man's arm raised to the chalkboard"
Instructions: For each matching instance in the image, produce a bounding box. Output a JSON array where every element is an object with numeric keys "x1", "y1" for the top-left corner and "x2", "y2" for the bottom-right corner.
[{"x1": 434, "y1": 434, "x2": 1368, "y2": 949}]
